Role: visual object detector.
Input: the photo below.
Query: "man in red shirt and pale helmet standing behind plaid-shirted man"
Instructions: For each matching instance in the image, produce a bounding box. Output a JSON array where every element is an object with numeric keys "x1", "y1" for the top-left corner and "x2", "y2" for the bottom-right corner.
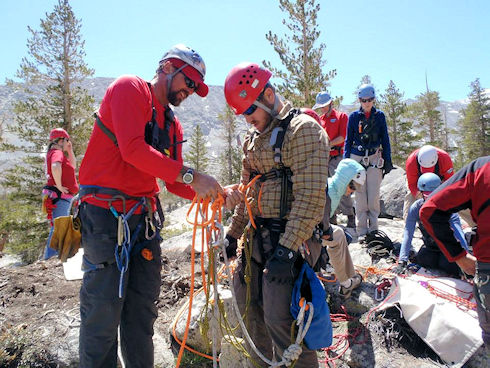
[{"x1": 313, "y1": 92, "x2": 356, "y2": 231}]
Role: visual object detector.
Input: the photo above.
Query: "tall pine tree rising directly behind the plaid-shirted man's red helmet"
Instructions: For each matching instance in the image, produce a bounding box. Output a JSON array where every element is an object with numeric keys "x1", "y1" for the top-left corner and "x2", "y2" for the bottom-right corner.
[{"x1": 263, "y1": 0, "x2": 337, "y2": 107}]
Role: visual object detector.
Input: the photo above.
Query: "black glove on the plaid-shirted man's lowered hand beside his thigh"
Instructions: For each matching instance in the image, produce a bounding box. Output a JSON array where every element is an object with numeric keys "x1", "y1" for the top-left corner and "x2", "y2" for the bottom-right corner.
[{"x1": 264, "y1": 244, "x2": 298, "y2": 285}]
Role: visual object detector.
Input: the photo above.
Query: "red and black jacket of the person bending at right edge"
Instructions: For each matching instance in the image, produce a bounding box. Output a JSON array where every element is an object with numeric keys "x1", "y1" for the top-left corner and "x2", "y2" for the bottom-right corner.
[{"x1": 420, "y1": 156, "x2": 490, "y2": 262}]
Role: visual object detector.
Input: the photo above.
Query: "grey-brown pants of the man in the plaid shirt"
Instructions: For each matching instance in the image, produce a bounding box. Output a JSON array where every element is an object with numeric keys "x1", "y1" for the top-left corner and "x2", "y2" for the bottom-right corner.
[{"x1": 233, "y1": 228, "x2": 318, "y2": 368}]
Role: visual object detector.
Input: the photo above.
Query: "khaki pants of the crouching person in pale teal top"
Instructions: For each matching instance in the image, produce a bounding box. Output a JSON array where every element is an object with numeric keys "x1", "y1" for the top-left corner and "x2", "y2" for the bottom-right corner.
[{"x1": 322, "y1": 225, "x2": 356, "y2": 282}]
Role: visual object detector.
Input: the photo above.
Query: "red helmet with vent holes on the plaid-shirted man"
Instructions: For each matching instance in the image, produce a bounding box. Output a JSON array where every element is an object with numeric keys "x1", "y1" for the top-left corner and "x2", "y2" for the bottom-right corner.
[{"x1": 225, "y1": 62, "x2": 272, "y2": 115}]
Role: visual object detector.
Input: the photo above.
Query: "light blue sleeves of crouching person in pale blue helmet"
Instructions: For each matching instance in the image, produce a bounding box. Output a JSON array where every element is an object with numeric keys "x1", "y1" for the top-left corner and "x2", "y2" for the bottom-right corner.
[{"x1": 399, "y1": 198, "x2": 468, "y2": 261}]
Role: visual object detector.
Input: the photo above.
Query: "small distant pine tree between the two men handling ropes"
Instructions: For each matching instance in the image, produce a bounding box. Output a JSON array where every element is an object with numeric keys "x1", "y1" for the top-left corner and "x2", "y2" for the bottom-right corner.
[{"x1": 218, "y1": 106, "x2": 242, "y2": 185}]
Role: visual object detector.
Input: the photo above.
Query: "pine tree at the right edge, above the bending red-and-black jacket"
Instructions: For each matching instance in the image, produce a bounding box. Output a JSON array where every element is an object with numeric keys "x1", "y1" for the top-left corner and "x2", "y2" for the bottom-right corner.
[{"x1": 459, "y1": 78, "x2": 490, "y2": 162}]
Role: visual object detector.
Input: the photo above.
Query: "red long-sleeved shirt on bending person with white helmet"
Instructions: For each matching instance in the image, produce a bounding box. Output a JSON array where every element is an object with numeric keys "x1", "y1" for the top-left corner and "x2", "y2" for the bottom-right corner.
[{"x1": 405, "y1": 147, "x2": 454, "y2": 197}]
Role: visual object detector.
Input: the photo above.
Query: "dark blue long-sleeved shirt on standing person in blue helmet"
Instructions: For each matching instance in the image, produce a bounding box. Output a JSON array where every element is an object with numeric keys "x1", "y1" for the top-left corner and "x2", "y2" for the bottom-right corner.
[{"x1": 344, "y1": 107, "x2": 391, "y2": 163}]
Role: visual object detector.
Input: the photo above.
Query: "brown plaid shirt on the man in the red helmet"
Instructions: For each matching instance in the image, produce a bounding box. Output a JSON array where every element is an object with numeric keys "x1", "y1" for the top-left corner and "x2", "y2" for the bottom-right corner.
[{"x1": 228, "y1": 102, "x2": 330, "y2": 250}]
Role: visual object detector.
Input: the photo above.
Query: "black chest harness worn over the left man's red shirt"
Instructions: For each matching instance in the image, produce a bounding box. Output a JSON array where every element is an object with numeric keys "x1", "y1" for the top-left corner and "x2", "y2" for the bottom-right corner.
[{"x1": 94, "y1": 83, "x2": 187, "y2": 160}]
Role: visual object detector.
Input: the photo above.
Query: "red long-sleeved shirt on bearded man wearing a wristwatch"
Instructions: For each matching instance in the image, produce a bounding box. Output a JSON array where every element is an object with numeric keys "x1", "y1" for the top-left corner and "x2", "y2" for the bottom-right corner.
[{"x1": 79, "y1": 75, "x2": 194, "y2": 211}]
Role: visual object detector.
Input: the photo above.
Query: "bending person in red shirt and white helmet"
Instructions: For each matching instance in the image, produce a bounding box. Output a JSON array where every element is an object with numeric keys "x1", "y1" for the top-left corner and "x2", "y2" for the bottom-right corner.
[{"x1": 403, "y1": 145, "x2": 454, "y2": 219}]
